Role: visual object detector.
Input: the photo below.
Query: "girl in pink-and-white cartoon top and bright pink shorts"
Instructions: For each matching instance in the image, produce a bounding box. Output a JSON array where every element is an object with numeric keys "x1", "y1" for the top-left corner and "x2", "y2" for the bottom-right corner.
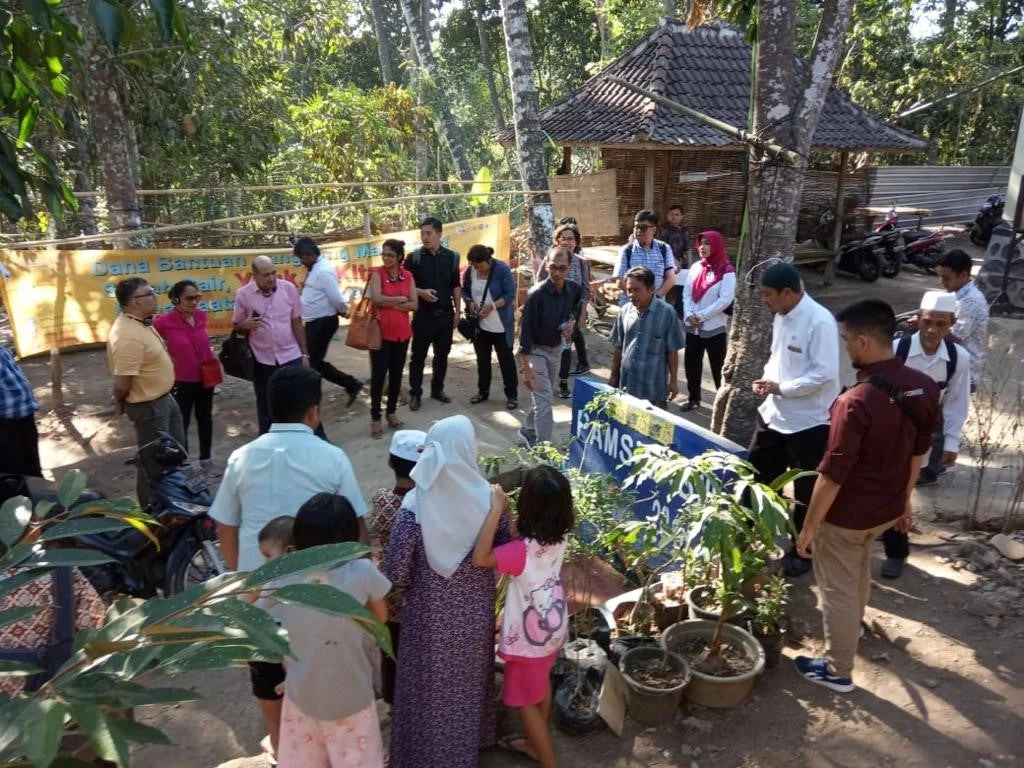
[{"x1": 473, "y1": 466, "x2": 575, "y2": 768}]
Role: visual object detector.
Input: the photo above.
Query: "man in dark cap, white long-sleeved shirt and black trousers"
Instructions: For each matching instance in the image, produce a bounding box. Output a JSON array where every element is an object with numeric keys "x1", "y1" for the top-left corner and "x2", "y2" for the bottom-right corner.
[{"x1": 749, "y1": 263, "x2": 840, "y2": 578}]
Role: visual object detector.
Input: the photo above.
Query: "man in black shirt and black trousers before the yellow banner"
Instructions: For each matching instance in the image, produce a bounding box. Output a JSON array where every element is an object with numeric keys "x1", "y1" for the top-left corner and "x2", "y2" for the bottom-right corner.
[{"x1": 404, "y1": 217, "x2": 462, "y2": 411}]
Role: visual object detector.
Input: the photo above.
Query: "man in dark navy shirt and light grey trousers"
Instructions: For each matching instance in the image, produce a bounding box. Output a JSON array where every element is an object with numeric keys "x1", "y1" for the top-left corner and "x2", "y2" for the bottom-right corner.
[{"x1": 519, "y1": 247, "x2": 583, "y2": 445}]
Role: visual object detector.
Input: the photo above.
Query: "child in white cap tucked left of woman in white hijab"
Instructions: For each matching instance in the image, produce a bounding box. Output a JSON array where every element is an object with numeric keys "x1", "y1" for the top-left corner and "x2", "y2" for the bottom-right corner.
[{"x1": 368, "y1": 429, "x2": 427, "y2": 703}]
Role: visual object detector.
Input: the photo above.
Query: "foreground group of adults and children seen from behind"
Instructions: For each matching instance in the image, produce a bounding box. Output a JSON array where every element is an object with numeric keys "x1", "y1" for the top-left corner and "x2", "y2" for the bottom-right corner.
[{"x1": 204, "y1": 367, "x2": 573, "y2": 768}]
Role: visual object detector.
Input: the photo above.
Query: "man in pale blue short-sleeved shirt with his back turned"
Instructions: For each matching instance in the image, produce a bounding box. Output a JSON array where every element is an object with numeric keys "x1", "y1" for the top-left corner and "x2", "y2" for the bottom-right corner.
[{"x1": 210, "y1": 367, "x2": 370, "y2": 748}]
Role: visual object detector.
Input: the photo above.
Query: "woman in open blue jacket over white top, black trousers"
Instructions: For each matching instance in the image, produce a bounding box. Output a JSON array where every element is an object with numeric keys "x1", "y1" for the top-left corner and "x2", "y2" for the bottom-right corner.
[{"x1": 459, "y1": 245, "x2": 519, "y2": 411}]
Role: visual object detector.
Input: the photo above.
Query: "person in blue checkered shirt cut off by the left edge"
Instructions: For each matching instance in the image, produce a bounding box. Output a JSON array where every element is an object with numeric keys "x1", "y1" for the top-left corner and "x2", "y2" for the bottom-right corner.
[{"x1": 0, "y1": 346, "x2": 43, "y2": 477}]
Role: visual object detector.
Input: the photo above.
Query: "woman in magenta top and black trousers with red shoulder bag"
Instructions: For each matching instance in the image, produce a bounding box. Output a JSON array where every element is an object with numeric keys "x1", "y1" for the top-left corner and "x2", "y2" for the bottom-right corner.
[{"x1": 153, "y1": 280, "x2": 223, "y2": 477}]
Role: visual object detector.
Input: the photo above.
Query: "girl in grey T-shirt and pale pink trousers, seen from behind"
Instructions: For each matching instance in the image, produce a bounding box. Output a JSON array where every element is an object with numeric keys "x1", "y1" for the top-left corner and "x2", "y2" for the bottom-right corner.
[{"x1": 271, "y1": 494, "x2": 391, "y2": 768}]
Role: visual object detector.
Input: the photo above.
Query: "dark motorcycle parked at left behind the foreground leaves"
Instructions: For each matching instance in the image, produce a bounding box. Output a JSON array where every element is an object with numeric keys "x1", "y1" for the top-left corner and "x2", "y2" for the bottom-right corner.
[{"x1": 0, "y1": 432, "x2": 227, "y2": 598}]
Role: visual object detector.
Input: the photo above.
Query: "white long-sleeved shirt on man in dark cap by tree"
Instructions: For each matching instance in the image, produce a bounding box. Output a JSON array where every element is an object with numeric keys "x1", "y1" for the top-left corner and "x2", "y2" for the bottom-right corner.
[{"x1": 758, "y1": 293, "x2": 840, "y2": 434}]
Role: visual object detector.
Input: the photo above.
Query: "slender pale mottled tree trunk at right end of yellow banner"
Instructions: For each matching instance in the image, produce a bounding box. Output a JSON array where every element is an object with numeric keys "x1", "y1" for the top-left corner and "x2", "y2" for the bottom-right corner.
[{"x1": 502, "y1": 0, "x2": 555, "y2": 259}]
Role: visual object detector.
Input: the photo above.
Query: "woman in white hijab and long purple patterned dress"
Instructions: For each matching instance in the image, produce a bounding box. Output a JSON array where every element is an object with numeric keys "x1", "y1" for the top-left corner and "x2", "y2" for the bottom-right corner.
[{"x1": 385, "y1": 416, "x2": 509, "y2": 768}]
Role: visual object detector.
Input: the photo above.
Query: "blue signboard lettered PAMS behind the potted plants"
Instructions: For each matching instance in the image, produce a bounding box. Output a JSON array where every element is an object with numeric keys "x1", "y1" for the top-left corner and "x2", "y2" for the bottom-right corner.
[{"x1": 569, "y1": 377, "x2": 746, "y2": 517}]
